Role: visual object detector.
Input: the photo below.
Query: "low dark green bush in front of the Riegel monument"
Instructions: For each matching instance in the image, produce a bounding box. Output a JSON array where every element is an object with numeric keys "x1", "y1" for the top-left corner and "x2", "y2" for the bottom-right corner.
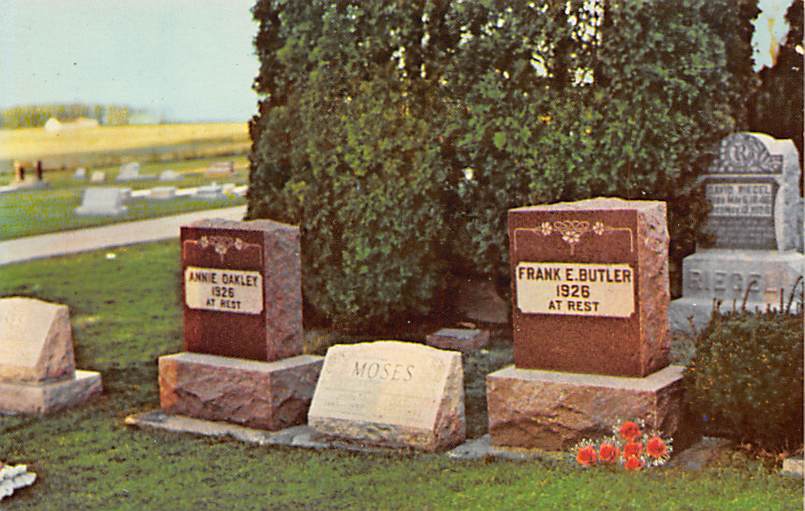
[{"x1": 685, "y1": 306, "x2": 803, "y2": 449}]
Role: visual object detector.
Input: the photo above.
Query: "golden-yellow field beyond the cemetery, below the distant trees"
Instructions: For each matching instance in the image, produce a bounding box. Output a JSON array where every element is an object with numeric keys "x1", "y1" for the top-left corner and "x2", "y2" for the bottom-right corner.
[{"x1": 0, "y1": 123, "x2": 250, "y2": 171}]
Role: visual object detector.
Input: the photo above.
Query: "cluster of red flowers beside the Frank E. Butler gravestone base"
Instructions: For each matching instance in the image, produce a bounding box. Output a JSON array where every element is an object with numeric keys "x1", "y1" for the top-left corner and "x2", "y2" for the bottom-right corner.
[{"x1": 572, "y1": 419, "x2": 673, "y2": 472}]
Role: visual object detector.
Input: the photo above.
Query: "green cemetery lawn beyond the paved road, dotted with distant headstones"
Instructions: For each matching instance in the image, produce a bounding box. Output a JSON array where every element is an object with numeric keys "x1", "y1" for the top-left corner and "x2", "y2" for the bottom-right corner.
[{"x1": 0, "y1": 157, "x2": 247, "y2": 240}]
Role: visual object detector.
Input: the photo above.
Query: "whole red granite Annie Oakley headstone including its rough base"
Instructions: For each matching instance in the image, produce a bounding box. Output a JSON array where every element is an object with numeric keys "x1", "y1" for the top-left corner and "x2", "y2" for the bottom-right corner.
[{"x1": 159, "y1": 220, "x2": 322, "y2": 430}]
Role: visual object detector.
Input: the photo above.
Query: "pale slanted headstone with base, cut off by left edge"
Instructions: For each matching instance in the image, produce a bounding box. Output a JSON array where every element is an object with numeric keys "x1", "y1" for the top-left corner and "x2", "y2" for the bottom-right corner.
[{"x1": 0, "y1": 297, "x2": 101, "y2": 414}]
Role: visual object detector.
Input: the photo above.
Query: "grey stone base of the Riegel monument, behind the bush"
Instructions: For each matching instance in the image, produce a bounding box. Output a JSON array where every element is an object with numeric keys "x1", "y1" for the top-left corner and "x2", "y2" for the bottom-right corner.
[{"x1": 668, "y1": 249, "x2": 805, "y2": 334}]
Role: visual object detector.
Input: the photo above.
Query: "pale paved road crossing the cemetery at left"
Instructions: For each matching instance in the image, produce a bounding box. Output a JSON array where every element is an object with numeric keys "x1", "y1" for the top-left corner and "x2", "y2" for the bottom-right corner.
[{"x1": 0, "y1": 206, "x2": 246, "y2": 265}]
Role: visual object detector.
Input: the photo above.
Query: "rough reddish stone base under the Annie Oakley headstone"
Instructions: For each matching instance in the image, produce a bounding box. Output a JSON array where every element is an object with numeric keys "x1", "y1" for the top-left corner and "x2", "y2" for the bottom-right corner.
[{"x1": 159, "y1": 352, "x2": 323, "y2": 431}]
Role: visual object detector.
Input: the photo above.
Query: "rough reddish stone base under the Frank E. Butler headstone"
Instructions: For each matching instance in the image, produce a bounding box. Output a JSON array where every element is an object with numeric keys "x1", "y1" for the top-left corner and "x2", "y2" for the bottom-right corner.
[{"x1": 486, "y1": 366, "x2": 696, "y2": 451}]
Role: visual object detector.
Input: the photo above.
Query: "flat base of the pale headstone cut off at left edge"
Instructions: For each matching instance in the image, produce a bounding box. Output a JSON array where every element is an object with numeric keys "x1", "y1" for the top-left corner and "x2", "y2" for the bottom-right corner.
[{"x1": 0, "y1": 370, "x2": 102, "y2": 415}]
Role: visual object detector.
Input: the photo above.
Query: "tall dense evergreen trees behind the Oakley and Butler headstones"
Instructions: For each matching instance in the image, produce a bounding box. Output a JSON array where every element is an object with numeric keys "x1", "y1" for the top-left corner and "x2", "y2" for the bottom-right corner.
[{"x1": 249, "y1": 0, "x2": 754, "y2": 324}]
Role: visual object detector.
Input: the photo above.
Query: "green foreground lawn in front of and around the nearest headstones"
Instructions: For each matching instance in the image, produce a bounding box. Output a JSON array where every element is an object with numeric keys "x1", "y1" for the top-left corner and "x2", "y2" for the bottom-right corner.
[{"x1": 0, "y1": 245, "x2": 803, "y2": 511}]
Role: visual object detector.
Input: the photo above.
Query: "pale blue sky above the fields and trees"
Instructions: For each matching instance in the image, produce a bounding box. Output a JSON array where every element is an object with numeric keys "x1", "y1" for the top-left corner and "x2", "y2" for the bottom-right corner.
[{"x1": 0, "y1": 0, "x2": 792, "y2": 121}]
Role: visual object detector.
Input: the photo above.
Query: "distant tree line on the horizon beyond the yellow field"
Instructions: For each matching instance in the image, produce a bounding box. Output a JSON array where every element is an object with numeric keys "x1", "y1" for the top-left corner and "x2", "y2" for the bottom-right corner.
[{"x1": 0, "y1": 103, "x2": 139, "y2": 129}]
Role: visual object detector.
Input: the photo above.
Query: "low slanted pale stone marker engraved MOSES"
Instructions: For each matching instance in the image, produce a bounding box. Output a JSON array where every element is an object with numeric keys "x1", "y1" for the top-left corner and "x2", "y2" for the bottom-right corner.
[{"x1": 308, "y1": 341, "x2": 465, "y2": 452}]
